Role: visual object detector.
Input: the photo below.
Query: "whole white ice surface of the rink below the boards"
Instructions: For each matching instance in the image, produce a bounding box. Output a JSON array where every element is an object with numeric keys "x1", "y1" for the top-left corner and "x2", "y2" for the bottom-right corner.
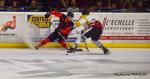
[{"x1": 0, "y1": 48, "x2": 150, "y2": 79}]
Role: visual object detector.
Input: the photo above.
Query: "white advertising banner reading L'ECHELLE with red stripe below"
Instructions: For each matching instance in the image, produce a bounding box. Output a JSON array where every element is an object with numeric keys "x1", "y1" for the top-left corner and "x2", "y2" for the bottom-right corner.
[{"x1": 91, "y1": 13, "x2": 150, "y2": 43}]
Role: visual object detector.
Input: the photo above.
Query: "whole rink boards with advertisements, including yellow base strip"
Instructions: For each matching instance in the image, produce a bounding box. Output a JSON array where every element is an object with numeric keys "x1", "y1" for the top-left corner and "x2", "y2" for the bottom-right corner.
[{"x1": 0, "y1": 12, "x2": 150, "y2": 48}]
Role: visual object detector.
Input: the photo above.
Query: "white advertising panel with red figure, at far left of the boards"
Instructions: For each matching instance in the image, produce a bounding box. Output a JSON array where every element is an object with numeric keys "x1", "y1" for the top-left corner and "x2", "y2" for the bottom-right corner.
[{"x1": 0, "y1": 13, "x2": 25, "y2": 43}]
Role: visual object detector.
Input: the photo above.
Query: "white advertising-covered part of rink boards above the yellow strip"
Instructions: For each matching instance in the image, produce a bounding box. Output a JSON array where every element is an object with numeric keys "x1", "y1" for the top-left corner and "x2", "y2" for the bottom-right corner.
[{"x1": 0, "y1": 12, "x2": 150, "y2": 47}]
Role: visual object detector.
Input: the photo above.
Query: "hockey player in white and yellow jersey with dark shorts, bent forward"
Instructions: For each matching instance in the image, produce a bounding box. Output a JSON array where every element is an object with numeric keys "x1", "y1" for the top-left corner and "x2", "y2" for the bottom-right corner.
[{"x1": 67, "y1": 10, "x2": 110, "y2": 54}]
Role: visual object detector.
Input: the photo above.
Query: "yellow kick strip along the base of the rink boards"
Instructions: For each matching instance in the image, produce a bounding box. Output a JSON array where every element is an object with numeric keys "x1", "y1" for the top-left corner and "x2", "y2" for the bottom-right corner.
[{"x1": 0, "y1": 43, "x2": 150, "y2": 48}]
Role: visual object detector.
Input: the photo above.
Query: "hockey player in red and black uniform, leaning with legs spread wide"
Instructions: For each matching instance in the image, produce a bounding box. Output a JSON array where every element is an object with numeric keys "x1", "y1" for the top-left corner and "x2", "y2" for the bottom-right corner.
[{"x1": 35, "y1": 10, "x2": 74, "y2": 49}]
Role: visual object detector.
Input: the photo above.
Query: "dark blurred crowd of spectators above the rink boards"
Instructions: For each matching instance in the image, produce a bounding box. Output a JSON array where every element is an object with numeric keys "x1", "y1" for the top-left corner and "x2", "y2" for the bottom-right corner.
[{"x1": 0, "y1": 0, "x2": 150, "y2": 12}]
